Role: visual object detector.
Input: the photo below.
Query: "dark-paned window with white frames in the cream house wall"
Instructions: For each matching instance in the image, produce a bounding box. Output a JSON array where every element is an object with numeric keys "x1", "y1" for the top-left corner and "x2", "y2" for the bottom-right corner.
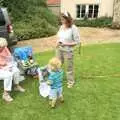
[{"x1": 77, "y1": 4, "x2": 99, "y2": 18}]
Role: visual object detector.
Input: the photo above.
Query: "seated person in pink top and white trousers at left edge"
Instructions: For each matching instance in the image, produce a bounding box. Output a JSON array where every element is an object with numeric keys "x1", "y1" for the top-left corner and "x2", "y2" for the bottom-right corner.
[{"x1": 0, "y1": 38, "x2": 25, "y2": 102}]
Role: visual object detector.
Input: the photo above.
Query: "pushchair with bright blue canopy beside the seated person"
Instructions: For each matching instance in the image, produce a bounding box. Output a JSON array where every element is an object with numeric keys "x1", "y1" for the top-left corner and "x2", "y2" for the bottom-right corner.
[{"x1": 13, "y1": 46, "x2": 39, "y2": 76}]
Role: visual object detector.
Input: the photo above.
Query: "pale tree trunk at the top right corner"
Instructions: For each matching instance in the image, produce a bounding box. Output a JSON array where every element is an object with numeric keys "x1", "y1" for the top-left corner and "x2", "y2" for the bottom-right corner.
[{"x1": 113, "y1": 0, "x2": 120, "y2": 29}]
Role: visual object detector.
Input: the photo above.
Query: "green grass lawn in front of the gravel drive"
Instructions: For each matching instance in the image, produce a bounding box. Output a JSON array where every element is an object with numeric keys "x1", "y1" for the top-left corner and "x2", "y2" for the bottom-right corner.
[{"x1": 0, "y1": 44, "x2": 120, "y2": 120}]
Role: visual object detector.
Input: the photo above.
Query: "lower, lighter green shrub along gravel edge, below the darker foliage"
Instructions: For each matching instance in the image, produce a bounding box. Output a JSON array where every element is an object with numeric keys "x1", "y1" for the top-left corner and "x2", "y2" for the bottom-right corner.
[{"x1": 14, "y1": 20, "x2": 57, "y2": 40}]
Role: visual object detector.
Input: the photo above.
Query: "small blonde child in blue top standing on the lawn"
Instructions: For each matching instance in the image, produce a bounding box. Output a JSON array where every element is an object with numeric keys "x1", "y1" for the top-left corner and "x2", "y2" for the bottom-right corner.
[{"x1": 48, "y1": 57, "x2": 64, "y2": 108}]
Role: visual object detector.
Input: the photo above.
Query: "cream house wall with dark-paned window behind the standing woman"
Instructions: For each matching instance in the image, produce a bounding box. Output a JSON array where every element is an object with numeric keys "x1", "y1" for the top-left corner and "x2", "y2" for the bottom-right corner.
[{"x1": 61, "y1": 0, "x2": 114, "y2": 19}]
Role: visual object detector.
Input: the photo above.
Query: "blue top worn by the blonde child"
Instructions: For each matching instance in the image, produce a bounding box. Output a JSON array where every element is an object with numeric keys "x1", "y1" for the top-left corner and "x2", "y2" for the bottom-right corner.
[{"x1": 48, "y1": 70, "x2": 63, "y2": 89}]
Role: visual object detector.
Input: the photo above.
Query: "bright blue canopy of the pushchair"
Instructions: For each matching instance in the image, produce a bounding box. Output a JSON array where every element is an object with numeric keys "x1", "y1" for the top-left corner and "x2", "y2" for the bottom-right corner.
[{"x1": 13, "y1": 46, "x2": 33, "y2": 60}]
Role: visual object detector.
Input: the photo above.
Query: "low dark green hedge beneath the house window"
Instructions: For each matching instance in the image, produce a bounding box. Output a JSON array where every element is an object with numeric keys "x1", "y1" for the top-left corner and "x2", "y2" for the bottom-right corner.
[{"x1": 75, "y1": 17, "x2": 112, "y2": 27}]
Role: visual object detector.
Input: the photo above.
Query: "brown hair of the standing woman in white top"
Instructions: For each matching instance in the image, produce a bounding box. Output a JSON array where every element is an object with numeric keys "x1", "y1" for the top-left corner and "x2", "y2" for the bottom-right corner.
[{"x1": 61, "y1": 12, "x2": 73, "y2": 27}]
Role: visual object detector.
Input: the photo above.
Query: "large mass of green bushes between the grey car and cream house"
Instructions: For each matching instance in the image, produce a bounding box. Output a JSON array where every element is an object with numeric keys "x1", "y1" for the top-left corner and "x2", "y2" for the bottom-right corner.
[{"x1": 1, "y1": 0, "x2": 58, "y2": 40}]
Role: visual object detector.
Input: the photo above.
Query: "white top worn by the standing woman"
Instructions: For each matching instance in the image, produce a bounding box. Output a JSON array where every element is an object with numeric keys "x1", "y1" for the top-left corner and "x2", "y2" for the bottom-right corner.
[{"x1": 57, "y1": 25, "x2": 80, "y2": 44}]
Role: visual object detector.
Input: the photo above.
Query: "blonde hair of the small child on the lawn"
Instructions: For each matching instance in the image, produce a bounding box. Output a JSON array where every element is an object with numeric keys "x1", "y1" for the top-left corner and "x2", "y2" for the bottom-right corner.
[{"x1": 49, "y1": 57, "x2": 62, "y2": 71}]
